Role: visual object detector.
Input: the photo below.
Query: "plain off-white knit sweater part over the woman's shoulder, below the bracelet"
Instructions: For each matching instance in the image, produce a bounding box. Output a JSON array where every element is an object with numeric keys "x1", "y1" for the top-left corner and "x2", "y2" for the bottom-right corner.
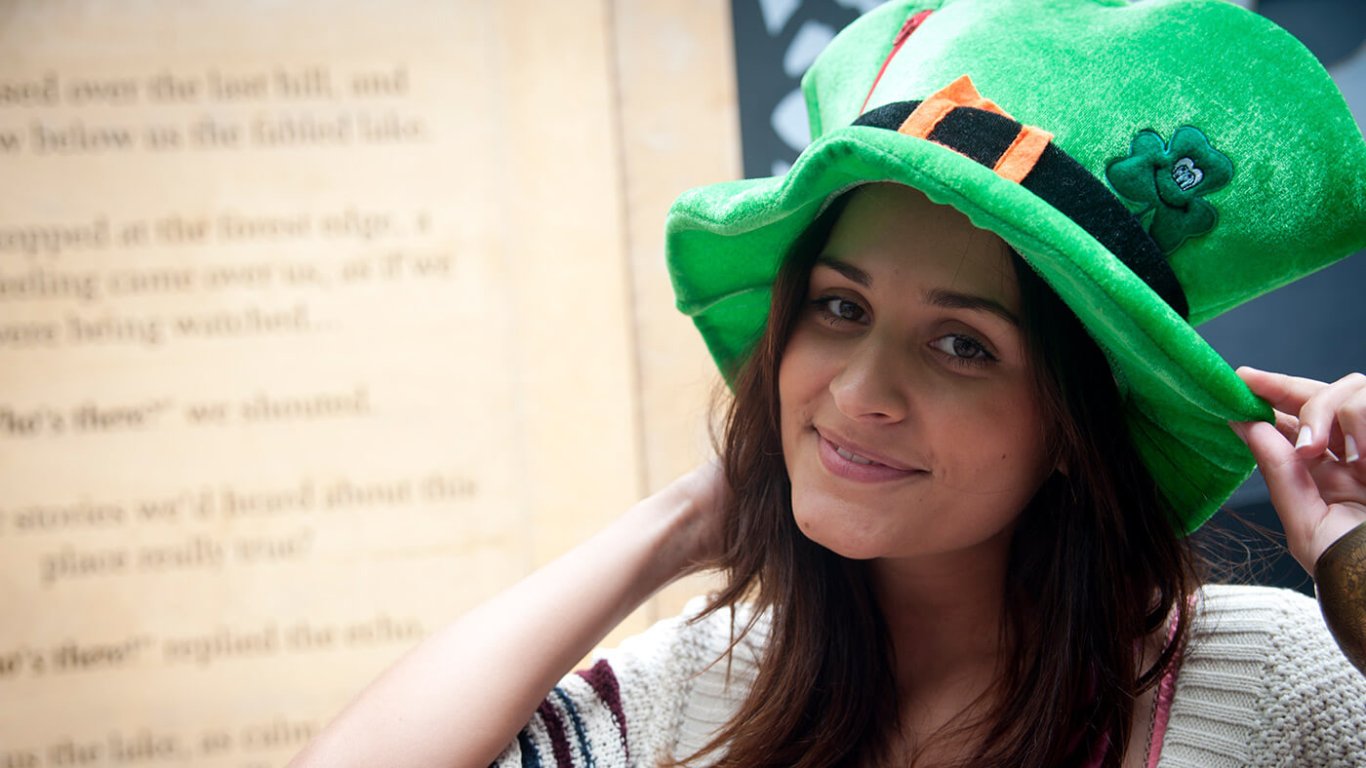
[{"x1": 1160, "y1": 586, "x2": 1366, "y2": 768}]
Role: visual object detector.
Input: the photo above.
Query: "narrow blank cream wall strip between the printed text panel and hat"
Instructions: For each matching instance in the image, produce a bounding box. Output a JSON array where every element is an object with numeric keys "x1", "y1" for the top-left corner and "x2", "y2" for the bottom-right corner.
[{"x1": 615, "y1": 0, "x2": 740, "y2": 618}]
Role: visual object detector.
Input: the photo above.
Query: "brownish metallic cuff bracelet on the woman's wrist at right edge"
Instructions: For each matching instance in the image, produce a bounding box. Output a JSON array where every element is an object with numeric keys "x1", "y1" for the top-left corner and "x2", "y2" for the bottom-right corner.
[{"x1": 1314, "y1": 523, "x2": 1366, "y2": 674}]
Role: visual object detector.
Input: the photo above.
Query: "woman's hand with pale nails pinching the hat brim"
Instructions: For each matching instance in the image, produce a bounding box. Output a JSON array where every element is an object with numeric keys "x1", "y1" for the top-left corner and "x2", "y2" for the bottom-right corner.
[{"x1": 1232, "y1": 368, "x2": 1366, "y2": 574}]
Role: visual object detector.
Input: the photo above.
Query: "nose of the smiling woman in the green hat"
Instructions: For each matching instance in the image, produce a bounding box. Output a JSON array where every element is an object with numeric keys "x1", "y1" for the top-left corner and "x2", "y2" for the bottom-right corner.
[{"x1": 831, "y1": 335, "x2": 908, "y2": 424}]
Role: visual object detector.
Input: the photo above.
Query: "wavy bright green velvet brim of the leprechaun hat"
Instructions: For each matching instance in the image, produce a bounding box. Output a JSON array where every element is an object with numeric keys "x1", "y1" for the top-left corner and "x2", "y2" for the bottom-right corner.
[{"x1": 667, "y1": 126, "x2": 1272, "y2": 532}]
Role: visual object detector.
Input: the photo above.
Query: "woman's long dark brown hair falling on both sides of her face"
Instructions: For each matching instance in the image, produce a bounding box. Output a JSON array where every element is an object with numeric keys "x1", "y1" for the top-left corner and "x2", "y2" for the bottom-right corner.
[{"x1": 684, "y1": 188, "x2": 1198, "y2": 768}]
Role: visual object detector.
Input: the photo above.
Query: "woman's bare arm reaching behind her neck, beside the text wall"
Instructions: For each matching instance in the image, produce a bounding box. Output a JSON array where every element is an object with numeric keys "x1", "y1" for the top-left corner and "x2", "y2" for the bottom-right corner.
[{"x1": 290, "y1": 465, "x2": 724, "y2": 768}]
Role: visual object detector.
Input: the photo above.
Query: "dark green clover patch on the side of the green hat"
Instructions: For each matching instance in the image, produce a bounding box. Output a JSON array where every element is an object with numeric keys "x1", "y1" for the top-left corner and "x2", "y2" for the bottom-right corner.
[{"x1": 1105, "y1": 126, "x2": 1233, "y2": 254}]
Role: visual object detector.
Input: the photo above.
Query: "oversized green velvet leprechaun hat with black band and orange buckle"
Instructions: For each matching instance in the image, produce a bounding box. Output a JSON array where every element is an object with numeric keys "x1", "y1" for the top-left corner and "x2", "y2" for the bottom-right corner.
[{"x1": 667, "y1": 0, "x2": 1366, "y2": 530}]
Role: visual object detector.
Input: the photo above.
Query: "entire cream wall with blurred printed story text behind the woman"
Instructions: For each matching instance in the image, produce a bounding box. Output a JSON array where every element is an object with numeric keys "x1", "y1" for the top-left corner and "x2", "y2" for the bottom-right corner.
[{"x1": 0, "y1": 0, "x2": 738, "y2": 768}]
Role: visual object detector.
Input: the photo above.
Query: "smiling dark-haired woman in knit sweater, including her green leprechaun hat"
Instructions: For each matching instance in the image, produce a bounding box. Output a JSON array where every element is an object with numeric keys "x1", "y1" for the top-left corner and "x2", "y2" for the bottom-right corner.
[{"x1": 296, "y1": 0, "x2": 1366, "y2": 767}]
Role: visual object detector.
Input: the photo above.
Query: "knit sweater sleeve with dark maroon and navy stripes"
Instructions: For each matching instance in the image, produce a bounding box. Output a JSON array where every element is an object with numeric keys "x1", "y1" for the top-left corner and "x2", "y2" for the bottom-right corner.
[{"x1": 494, "y1": 599, "x2": 766, "y2": 768}]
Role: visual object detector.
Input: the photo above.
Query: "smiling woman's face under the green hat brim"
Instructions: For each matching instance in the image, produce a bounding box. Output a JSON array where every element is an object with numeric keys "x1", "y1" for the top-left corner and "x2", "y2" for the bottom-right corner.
[{"x1": 779, "y1": 183, "x2": 1053, "y2": 559}]
